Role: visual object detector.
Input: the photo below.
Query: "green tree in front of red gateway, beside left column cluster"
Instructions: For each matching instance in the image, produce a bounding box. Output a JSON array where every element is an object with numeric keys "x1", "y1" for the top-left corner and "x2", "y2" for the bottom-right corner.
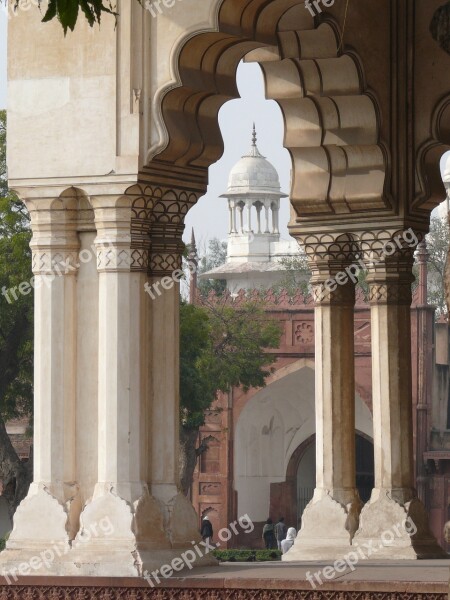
[{"x1": 180, "y1": 302, "x2": 281, "y2": 494}]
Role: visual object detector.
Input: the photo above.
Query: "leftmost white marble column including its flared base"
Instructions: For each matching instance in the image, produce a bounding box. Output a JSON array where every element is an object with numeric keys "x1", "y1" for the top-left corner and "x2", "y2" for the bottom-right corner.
[{"x1": 2, "y1": 197, "x2": 79, "y2": 562}]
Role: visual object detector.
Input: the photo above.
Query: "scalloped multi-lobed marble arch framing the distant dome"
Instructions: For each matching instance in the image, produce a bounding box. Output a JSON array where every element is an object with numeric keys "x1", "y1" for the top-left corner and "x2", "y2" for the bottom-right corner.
[{"x1": 152, "y1": 0, "x2": 391, "y2": 219}]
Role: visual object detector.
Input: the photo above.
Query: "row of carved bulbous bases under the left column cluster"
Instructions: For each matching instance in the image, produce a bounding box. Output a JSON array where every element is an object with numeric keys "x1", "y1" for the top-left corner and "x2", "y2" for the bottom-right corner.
[{"x1": 0, "y1": 485, "x2": 217, "y2": 583}]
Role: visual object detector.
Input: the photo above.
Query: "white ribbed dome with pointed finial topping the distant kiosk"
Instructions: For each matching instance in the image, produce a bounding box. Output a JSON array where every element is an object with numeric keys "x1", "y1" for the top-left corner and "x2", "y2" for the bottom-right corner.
[{"x1": 225, "y1": 130, "x2": 284, "y2": 197}]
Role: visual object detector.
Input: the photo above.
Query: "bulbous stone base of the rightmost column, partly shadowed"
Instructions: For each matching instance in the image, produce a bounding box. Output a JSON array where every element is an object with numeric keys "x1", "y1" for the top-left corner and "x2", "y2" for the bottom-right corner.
[{"x1": 353, "y1": 489, "x2": 448, "y2": 560}]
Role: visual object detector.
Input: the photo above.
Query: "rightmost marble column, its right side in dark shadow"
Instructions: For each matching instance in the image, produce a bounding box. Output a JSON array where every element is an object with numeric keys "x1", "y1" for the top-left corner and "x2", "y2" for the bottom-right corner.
[{"x1": 354, "y1": 248, "x2": 442, "y2": 558}]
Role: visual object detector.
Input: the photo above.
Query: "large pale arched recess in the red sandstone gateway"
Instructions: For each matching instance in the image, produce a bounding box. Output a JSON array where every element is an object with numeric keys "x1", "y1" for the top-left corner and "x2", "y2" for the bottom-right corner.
[{"x1": 233, "y1": 359, "x2": 372, "y2": 524}]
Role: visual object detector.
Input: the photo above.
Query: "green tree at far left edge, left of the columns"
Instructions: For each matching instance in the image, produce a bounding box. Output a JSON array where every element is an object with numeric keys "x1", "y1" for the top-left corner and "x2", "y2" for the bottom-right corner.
[{"x1": 0, "y1": 111, "x2": 33, "y2": 514}]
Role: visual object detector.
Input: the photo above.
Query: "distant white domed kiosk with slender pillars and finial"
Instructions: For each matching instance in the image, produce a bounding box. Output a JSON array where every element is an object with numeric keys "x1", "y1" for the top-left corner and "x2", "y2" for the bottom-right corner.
[{"x1": 221, "y1": 124, "x2": 288, "y2": 236}]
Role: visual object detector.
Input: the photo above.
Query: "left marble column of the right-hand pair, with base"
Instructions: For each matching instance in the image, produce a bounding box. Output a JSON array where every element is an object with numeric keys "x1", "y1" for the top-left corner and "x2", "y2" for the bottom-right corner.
[{"x1": 283, "y1": 246, "x2": 362, "y2": 561}]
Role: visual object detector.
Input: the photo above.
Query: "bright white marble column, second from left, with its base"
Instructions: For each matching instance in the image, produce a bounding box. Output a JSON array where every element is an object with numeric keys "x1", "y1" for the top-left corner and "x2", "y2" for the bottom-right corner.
[{"x1": 72, "y1": 195, "x2": 166, "y2": 576}]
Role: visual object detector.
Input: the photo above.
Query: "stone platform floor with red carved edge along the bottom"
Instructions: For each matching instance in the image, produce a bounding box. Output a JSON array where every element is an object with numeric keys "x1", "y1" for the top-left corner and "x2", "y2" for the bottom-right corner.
[{"x1": 0, "y1": 560, "x2": 450, "y2": 600}]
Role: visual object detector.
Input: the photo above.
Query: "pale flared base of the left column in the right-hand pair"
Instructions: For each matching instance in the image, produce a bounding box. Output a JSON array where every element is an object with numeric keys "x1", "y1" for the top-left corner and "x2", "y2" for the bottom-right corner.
[{"x1": 282, "y1": 489, "x2": 362, "y2": 562}]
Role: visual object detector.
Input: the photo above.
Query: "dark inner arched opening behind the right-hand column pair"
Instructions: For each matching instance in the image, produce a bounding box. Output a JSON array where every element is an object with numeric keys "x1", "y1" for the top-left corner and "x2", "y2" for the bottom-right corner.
[{"x1": 296, "y1": 433, "x2": 374, "y2": 528}]
